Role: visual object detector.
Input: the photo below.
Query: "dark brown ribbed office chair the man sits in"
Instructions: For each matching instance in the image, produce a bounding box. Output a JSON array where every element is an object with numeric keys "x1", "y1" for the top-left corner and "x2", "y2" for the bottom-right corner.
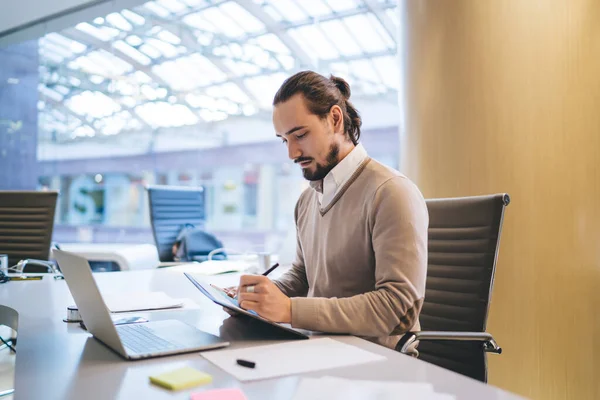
[{"x1": 396, "y1": 194, "x2": 510, "y2": 382}]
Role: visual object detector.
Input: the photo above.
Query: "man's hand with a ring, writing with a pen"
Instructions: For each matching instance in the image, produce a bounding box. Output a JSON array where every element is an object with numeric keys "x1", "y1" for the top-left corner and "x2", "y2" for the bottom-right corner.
[{"x1": 237, "y1": 275, "x2": 292, "y2": 323}]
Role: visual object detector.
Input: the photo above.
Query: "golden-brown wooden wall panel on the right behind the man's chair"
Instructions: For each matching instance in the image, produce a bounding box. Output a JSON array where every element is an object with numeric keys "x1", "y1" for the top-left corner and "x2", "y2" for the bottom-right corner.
[{"x1": 400, "y1": 0, "x2": 600, "y2": 399}]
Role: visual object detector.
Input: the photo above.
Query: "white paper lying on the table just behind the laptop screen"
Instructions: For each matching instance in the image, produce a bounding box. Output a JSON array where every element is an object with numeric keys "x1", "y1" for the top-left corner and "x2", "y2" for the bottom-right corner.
[{"x1": 102, "y1": 292, "x2": 184, "y2": 312}]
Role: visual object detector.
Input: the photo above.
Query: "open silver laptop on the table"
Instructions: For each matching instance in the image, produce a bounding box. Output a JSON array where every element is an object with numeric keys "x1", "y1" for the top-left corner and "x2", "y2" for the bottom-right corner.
[{"x1": 53, "y1": 250, "x2": 229, "y2": 360}]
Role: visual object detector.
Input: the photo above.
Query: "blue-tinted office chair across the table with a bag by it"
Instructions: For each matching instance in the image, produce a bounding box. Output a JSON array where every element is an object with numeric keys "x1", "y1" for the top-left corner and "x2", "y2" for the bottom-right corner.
[{"x1": 147, "y1": 186, "x2": 222, "y2": 262}]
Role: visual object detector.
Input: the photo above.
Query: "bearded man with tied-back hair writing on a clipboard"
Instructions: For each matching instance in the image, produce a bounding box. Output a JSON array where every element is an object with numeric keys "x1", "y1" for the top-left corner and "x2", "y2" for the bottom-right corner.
[{"x1": 232, "y1": 71, "x2": 429, "y2": 348}]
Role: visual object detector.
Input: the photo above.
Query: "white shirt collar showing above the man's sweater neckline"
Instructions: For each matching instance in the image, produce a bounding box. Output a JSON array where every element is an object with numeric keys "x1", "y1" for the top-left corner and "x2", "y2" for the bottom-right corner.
[{"x1": 310, "y1": 143, "x2": 369, "y2": 209}]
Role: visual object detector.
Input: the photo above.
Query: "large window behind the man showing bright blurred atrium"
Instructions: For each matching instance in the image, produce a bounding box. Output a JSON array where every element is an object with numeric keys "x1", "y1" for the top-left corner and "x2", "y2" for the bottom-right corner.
[{"x1": 0, "y1": 0, "x2": 399, "y2": 256}]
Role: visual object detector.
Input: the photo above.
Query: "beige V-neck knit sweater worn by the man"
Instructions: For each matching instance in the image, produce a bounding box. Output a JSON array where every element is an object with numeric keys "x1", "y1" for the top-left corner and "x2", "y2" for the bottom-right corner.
[{"x1": 275, "y1": 158, "x2": 429, "y2": 348}]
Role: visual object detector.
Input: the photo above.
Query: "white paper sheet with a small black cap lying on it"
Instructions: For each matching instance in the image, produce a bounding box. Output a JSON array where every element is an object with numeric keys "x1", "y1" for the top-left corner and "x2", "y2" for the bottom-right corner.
[{"x1": 202, "y1": 338, "x2": 386, "y2": 381}]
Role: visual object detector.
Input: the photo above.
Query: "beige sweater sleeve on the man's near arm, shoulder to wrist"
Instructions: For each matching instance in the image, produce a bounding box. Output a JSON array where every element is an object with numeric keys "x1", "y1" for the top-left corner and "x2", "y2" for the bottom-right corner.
[{"x1": 292, "y1": 176, "x2": 429, "y2": 336}]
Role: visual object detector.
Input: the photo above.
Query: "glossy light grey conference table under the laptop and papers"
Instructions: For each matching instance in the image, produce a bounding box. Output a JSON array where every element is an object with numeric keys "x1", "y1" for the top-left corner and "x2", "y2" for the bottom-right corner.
[{"x1": 0, "y1": 268, "x2": 520, "y2": 400}]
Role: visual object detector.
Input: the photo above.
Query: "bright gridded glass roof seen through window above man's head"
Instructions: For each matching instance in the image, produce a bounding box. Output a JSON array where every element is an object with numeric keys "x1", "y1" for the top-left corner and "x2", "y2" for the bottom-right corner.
[{"x1": 39, "y1": 0, "x2": 399, "y2": 142}]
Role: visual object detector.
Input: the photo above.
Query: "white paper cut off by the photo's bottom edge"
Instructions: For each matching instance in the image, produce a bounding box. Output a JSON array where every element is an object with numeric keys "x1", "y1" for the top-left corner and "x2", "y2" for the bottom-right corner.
[{"x1": 293, "y1": 376, "x2": 454, "y2": 400}]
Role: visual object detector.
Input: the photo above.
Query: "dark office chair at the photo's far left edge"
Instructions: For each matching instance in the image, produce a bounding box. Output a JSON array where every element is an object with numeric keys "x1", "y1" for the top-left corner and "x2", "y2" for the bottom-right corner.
[{"x1": 0, "y1": 191, "x2": 58, "y2": 272}]
